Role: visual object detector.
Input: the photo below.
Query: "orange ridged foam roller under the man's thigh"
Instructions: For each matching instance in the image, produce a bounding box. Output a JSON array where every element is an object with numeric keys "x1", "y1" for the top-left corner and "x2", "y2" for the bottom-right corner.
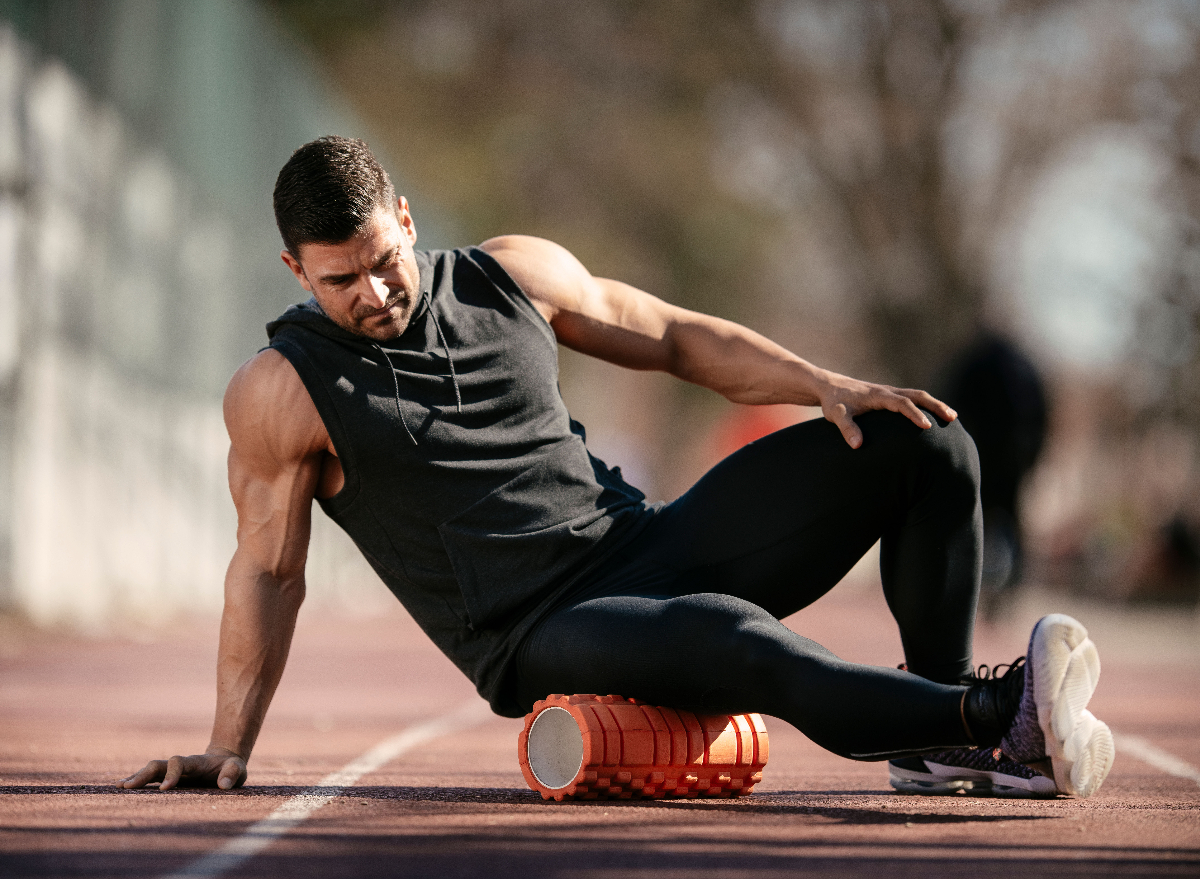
[{"x1": 517, "y1": 694, "x2": 767, "y2": 801}]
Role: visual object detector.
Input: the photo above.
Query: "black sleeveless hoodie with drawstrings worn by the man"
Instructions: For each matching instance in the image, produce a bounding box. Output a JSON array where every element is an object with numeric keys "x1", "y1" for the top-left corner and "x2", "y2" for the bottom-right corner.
[{"x1": 266, "y1": 247, "x2": 649, "y2": 717}]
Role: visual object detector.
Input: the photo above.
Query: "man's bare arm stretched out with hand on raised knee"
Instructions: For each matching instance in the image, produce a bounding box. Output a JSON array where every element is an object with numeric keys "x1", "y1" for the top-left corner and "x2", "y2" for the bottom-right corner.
[{"x1": 482, "y1": 235, "x2": 955, "y2": 448}]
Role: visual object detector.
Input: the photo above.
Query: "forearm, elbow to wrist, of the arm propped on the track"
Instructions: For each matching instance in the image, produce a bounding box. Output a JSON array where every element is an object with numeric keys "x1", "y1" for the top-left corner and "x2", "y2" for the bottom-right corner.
[{"x1": 209, "y1": 554, "x2": 305, "y2": 759}]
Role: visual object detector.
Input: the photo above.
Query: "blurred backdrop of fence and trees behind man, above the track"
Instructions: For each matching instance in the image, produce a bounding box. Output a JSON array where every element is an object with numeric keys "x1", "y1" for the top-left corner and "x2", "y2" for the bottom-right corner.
[{"x1": 0, "y1": 0, "x2": 1200, "y2": 628}]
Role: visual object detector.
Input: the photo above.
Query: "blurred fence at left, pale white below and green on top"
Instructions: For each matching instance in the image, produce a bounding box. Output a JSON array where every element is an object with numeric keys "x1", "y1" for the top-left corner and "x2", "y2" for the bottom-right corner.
[{"x1": 0, "y1": 0, "x2": 448, "y2": 626}]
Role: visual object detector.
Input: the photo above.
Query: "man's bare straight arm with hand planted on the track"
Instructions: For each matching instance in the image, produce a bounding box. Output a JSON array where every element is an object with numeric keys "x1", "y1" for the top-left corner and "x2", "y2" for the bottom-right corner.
[{"x1": 120, "y1": 349, "x2": 329, "y2": 790}]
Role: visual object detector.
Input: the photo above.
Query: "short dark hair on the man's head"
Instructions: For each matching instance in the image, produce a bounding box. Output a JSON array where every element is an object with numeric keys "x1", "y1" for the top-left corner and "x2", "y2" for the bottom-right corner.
[{"x1": 275, "y1": 136, "x2": 396, "y2": 257}]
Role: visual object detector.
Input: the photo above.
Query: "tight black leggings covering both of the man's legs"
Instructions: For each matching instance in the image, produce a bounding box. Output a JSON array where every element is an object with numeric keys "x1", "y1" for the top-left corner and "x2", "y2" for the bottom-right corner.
[{"x1": 516, "y1": 412, "x2": 982, "y2": 760}]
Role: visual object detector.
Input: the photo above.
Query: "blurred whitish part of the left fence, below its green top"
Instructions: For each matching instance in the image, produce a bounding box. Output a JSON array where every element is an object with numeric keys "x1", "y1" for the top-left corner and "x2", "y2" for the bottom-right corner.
[{"x1": 0, "y1": 20, "x2": 395, "y2": 628}]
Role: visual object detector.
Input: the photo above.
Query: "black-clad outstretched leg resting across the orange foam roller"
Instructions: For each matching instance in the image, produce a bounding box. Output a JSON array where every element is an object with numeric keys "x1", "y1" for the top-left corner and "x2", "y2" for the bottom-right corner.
[{"x1": 515, "y1": 583, "x2": 966, "y2": 759}]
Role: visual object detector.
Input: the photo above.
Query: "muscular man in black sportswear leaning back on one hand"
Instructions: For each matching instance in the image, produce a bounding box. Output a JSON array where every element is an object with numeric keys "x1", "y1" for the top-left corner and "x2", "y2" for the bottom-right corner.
[{"x1": 121, "y1": 137, "x2": 1112, "y2": 796}]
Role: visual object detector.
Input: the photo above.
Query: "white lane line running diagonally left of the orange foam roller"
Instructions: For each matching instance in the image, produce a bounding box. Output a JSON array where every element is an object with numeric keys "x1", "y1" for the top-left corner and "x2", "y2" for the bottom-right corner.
[{"x1": 164, "y1": 699, "x2": 492, "y2": 879}]
